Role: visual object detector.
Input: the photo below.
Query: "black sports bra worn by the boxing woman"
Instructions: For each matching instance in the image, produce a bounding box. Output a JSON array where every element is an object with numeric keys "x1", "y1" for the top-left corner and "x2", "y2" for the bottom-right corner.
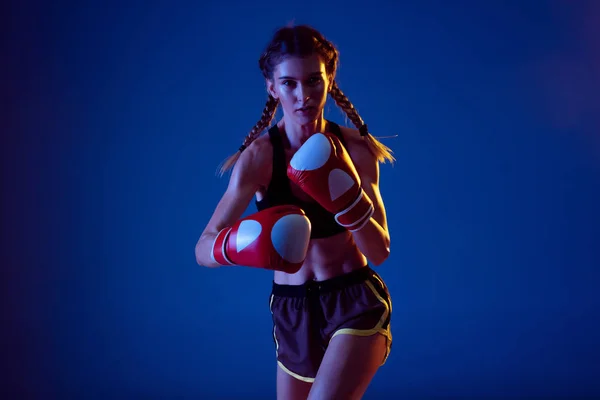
[{"x1": 256, "y1": 121, "x2": 346, "y2": 239}]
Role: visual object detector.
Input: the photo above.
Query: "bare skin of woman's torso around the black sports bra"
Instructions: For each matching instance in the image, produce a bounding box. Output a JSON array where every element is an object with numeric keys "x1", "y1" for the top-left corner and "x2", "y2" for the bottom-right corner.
[{"x1": 255, "y1": 120, "x2": 367, "y2": 285}]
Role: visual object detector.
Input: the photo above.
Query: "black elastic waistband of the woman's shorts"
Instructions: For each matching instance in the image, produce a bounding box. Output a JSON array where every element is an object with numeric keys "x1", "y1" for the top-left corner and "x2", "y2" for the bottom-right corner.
[{"x1": 272, "y1": 265, "x2": 375, "y2": 297}]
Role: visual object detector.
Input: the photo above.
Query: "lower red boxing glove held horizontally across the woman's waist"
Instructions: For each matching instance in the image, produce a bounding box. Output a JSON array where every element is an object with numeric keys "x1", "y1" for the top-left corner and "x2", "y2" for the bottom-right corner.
[{"x1": 211, "y1": 205, "x2": 311, "y2": 273}]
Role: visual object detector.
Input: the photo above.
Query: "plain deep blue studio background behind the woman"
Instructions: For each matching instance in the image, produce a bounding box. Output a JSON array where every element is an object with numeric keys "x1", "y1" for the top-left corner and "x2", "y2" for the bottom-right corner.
[{"x1": 0, "y1": 0, "x2": 600, "y2": 399}]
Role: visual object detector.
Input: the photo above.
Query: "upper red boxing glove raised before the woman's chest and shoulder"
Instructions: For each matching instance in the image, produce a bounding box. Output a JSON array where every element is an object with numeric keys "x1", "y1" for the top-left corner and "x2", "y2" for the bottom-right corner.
[{"x1": 287, "y1": 133, "x2": 375, "y2": 232}]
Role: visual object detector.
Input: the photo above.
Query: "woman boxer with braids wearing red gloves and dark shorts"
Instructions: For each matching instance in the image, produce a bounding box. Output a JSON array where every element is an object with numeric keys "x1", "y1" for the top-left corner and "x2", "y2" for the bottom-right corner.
[{"x1": 196, "y1": 26, "x2": 394, "y2": 399}]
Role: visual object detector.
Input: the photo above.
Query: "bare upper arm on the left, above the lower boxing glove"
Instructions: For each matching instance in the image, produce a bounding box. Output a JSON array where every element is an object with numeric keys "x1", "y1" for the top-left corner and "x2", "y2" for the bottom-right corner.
[{"x1": 202, "y1": 143, "x2": 268, "y2": 235}]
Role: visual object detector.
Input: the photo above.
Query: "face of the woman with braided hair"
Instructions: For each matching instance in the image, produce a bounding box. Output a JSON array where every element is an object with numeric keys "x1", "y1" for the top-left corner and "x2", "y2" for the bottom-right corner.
[{"x1": 267, "y1": 54, "x2": 330, "y2": 125}]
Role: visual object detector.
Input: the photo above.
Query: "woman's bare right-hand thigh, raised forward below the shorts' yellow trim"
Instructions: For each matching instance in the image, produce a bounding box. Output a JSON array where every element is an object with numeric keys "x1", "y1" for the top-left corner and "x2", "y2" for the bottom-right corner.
[{"x1": 308, "y1": 333, "x2": 388, "y2": 400}]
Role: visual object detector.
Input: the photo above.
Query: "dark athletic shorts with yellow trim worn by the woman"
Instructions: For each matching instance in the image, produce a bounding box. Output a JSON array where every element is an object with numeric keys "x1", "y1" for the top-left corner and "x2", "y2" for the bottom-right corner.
[{"x1": 270, "y1": 266, "x2": 392, "y2": 382}]
